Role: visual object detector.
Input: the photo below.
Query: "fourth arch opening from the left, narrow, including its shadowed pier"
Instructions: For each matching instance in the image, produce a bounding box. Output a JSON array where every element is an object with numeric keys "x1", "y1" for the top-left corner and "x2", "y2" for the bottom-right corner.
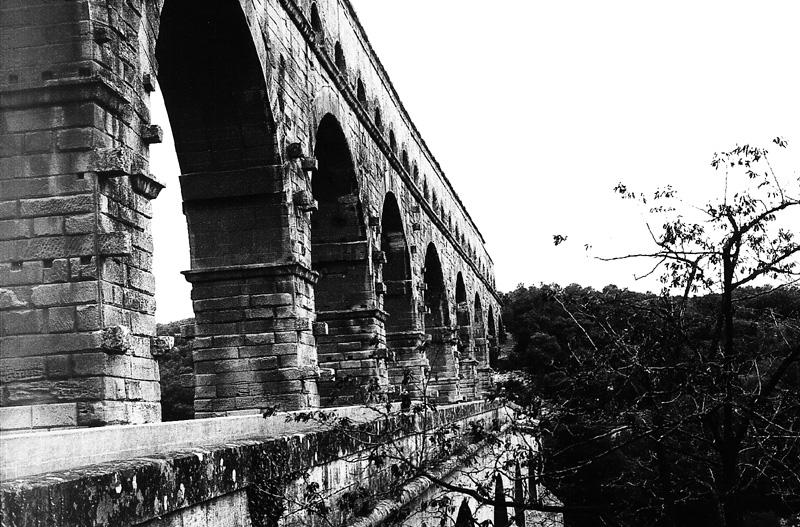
[{"x1": 424, "y1": 243, "x2": 459, "y2": 401}]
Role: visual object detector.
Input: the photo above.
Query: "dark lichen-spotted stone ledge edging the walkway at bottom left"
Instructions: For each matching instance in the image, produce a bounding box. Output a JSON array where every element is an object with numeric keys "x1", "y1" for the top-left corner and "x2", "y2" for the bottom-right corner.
[{"x1": 0, "y1": 402, "x2": 500, "y2": 527}]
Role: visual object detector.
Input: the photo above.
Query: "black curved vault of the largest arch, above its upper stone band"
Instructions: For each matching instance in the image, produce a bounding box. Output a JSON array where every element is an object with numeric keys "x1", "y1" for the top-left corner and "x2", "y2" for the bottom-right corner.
[{"x1": 156, "y1": 0, "x2": 278, "y2": 173}]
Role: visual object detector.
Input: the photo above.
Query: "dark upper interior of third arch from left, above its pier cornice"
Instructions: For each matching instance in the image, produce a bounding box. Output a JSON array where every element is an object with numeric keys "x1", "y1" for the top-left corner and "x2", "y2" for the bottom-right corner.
[{"x1": 381, "y1": 192, "x2": 414, "y2": 333}]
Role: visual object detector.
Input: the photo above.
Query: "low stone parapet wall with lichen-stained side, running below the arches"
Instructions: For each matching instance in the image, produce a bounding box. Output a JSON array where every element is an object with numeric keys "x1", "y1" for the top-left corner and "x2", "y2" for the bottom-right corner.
[{"x1": 0, "y1": 402, "x2": 544, "y2": 527}]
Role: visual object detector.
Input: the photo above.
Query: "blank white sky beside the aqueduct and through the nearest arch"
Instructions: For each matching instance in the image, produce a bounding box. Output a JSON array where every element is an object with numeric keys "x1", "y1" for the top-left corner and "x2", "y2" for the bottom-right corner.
[{"x1": 147, "y1": 0, "x2": 800, "y2": 321}]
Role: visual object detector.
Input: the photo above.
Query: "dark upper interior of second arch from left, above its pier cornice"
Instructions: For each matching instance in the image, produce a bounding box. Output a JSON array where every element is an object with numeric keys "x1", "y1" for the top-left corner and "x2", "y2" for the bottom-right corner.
[{"x1": 311, "y1": 114, "x2": 371, "y2": 311}]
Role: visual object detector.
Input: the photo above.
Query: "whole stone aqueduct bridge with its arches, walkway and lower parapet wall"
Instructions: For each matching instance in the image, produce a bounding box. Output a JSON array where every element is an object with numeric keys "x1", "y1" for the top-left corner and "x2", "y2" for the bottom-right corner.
[{"x1": 0, "y1": 0, "x2": 548, "y2": 527}]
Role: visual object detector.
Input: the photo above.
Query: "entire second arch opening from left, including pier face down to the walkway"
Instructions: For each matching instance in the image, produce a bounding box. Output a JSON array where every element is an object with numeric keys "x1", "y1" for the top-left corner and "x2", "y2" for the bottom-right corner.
[{"x1": 311, "y1": 113, "x2": 388, "y2": 405}]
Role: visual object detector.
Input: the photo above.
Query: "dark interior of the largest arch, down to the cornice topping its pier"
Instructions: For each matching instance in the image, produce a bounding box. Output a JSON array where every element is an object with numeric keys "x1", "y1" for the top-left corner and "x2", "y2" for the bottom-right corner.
[{"x1": 156, "y1": 0, "x2": 281, "y2": 269}]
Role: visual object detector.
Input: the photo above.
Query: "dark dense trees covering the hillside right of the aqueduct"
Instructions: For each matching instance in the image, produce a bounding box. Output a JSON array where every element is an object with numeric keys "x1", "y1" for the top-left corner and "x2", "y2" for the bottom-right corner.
[{"x1": 504, "y1": 285, "x2": 800, "y2": 526}]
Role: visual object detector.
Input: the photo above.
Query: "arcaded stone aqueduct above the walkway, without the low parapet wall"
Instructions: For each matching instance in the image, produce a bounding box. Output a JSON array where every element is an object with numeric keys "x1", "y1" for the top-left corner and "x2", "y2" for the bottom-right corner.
[{"x1": 0, "y1": 0, "x2": 502, "y2": 431}]
